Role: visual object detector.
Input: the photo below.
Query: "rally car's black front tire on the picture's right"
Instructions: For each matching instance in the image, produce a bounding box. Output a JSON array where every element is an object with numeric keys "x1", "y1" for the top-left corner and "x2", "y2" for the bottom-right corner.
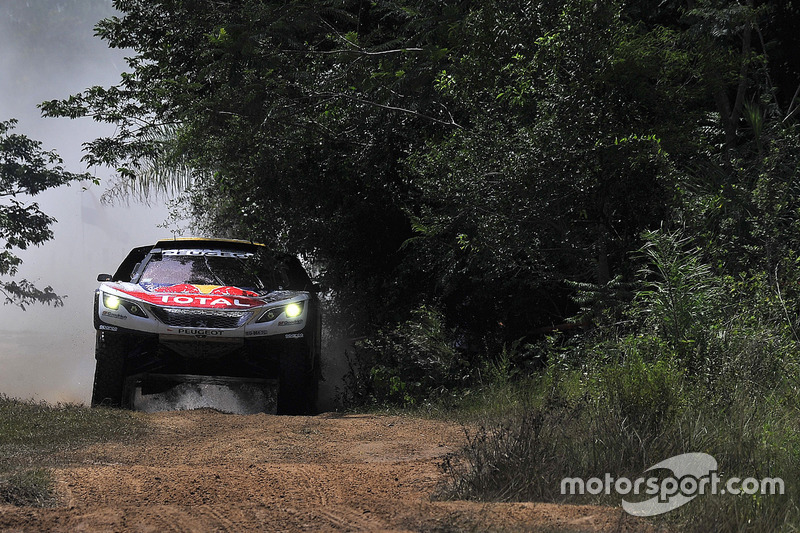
[{"x1": 278, "y1": 349, "x2": 318, "y2": 415}]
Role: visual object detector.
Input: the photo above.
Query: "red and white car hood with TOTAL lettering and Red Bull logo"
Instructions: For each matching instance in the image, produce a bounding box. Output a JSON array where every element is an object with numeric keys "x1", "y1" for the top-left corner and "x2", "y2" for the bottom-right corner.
[{"x1": 103, "y1": 282, "x2": 304, "y2": 310}]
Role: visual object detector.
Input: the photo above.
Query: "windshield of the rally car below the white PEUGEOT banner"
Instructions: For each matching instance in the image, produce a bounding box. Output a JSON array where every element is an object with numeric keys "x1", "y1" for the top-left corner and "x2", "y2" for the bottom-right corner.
[{"x1": 139, "y1": 250, "x2": 288, "y2": 292}]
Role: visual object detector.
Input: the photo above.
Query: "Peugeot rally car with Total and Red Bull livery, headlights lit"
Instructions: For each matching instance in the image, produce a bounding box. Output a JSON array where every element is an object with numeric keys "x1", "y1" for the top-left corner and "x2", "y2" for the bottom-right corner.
[{"x1": 92, "y1": 239, "x2": 321, "y2": 414}]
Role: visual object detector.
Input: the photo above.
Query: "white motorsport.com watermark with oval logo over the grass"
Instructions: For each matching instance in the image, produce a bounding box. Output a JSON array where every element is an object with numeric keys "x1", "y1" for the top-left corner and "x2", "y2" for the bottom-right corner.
[{"x1": 561, "y1": 453, "x2": 784, "y2": 516}]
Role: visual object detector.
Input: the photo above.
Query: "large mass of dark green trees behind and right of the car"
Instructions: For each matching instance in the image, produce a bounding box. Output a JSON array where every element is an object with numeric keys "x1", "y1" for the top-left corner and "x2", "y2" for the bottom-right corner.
[{"x1": 42, "y1": 0, "x2": 800, "y2": 403}]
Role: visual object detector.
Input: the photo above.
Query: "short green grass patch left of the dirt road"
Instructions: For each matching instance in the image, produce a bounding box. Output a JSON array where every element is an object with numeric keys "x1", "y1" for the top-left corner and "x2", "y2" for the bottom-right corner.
[{"x1": 0, "y1": 395, "x2": 145, "y2": 506}]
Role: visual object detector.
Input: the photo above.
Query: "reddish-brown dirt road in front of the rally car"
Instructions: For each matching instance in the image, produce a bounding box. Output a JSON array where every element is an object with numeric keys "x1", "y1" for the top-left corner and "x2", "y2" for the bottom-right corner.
[{"x1": 0, "y1": 410, "x2": 641, "y2": 532}]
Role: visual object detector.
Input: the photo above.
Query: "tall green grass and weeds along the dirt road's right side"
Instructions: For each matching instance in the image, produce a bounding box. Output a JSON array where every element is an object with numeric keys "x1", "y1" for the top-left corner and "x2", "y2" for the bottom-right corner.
[{"x1": 439, "y1": 361, "x2": 800, "y2": 532}]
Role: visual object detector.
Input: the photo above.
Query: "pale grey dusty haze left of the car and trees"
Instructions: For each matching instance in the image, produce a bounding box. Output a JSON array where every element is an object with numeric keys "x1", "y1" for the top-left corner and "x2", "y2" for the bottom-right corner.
[{"x1": 0, "y1": 0, "x2": 170, "y2": 404}]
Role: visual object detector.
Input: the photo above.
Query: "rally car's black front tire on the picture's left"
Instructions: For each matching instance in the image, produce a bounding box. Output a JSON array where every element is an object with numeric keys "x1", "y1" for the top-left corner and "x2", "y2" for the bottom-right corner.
[{"x1": 92, "y1": 331, "x2": 126, "y2": 407}]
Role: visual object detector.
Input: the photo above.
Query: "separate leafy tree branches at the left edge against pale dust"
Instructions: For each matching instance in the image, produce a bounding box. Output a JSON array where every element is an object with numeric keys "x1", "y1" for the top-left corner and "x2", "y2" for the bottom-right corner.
[{"x1": 0, "y1": 119, "x2": 89, "y2": 309}]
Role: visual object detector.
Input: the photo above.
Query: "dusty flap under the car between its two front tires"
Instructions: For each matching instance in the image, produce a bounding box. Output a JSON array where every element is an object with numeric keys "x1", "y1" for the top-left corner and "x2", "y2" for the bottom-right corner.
[{"x1": 124, "y1": 374, "x2": 278, "y2": 415}]
